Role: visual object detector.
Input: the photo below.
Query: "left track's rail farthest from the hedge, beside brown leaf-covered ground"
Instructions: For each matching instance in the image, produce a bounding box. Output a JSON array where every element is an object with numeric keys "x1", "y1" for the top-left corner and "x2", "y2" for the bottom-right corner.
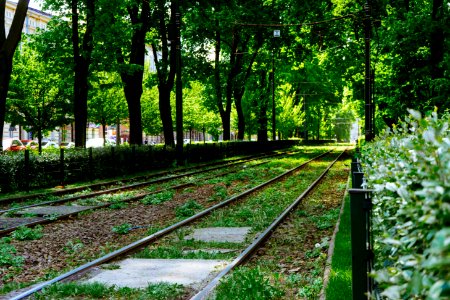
[{"x1": 0, "y1": 161, "x2": 269, "y2": 237}]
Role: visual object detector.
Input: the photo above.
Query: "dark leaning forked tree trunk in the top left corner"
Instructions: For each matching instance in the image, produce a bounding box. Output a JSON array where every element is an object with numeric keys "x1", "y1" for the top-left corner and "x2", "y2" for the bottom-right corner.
[{"x1": 0, "y1": 0, "x2": 29, "y2": 151}]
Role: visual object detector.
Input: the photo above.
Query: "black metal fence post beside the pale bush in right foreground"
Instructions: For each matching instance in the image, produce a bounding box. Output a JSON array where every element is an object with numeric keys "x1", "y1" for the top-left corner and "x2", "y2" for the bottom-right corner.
[{"x1": 349, "y1": 154, "x2": 374, "y2": 300}]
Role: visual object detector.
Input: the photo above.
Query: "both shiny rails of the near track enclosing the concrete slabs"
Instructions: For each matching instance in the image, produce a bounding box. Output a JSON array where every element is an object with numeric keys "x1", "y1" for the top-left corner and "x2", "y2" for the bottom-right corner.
[{"x1": 3, "y1": 152, "x2": 344, "y2": 299}]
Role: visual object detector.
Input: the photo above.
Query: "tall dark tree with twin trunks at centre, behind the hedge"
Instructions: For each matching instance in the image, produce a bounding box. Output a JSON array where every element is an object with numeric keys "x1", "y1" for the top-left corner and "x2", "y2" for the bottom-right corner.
[{"x1": 185, "y1": 0, "x2": 269, "y2": 140}]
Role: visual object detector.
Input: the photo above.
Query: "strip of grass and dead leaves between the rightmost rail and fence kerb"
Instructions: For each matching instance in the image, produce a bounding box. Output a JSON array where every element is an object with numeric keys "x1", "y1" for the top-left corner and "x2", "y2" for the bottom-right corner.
[{"x1": 214, "y1": 154, "x2": 351, "y2": 300}]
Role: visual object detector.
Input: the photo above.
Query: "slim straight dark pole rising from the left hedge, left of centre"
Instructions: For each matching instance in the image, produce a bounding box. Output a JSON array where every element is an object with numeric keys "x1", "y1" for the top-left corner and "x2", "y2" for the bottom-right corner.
[{"x1": 175, "y1": 0, "x2": 183, "y2": 165}]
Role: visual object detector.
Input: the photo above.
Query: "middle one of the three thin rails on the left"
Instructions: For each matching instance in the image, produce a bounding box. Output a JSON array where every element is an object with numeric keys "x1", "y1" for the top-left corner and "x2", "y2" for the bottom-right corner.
[{"x1": 0, "y1": 153, "x2": 292, "y2": 216}]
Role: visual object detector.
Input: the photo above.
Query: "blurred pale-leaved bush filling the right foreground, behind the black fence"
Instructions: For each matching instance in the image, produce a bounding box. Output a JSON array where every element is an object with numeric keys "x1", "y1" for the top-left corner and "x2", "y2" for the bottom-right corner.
[{"x1": 361, "y1": 110, "x2": 450, "y2": 299}]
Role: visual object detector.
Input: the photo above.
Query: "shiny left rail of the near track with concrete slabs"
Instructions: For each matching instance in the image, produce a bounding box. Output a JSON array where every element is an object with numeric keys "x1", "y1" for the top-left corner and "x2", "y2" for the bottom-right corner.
[{"x1": 10, "y1": 150, "x2": 332, "y2": 300}]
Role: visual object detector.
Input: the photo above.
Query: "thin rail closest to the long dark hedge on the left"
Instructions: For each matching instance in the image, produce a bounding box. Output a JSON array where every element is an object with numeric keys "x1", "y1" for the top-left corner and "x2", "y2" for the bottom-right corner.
[{"x1": 0, "y1": 151, "x2": 285, "y2": 205}]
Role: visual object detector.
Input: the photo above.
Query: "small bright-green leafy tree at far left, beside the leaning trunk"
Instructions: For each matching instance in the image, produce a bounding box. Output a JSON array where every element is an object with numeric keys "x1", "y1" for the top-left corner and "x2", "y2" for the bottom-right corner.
[{"x1": 7, "y1": 44, "x2": 71, "y2": 152}]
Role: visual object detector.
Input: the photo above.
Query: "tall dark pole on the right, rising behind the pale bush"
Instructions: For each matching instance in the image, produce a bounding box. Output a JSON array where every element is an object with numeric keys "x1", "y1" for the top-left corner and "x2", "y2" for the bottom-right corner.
[{"x1": 364, "y1": 0, "x2": 375, "y2": 142}]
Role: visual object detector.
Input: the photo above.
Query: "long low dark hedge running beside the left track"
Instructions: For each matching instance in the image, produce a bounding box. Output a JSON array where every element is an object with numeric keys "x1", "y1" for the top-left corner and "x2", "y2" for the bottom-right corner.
[{"x1": 0, "y1": 140, "x2": 312, "y2": 192}]
